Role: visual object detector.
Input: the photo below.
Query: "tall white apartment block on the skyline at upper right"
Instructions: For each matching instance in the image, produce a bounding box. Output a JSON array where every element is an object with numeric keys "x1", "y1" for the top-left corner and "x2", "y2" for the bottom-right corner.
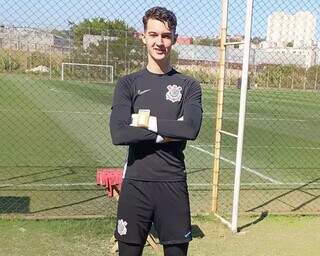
[{"x1": 262, "y1": 11, "x2": 316, "y2": 48}]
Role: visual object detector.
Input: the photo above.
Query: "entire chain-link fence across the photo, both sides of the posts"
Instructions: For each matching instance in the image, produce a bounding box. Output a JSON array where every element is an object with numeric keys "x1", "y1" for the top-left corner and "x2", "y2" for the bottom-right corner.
[{"x1": 0, "y1": 0, "x2": 320, "y2": 220}]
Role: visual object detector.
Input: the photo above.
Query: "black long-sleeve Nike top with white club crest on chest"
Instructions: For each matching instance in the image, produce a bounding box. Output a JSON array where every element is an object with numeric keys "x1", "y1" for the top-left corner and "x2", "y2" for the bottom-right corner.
[{"x1": 110, "y1": 69, "x2": 202, "y2": 181}]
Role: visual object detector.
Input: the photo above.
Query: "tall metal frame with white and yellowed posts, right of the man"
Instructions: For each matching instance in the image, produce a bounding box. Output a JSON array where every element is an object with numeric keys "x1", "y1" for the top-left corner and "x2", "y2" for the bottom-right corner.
[{"x1": 212, "y1": 0, "x2": 254, "y2": 233}]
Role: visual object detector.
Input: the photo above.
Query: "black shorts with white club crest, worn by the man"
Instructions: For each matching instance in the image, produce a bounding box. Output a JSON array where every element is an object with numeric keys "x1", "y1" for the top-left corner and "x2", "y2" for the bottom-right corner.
[{"x1": 115, "y1": 179, "x2": 192, "y2": 244}]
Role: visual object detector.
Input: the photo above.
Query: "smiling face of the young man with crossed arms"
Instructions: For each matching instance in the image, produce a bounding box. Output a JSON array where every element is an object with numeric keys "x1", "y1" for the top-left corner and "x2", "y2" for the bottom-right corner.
[{"x1": 142, "y1": 19, "x2": 177, "y2": 61}]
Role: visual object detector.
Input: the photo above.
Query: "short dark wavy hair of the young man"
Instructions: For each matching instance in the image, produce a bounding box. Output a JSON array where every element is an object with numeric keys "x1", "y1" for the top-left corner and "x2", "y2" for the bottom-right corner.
[{"x1": 142, "y1": 6, "x2": 177, "y2": 32}]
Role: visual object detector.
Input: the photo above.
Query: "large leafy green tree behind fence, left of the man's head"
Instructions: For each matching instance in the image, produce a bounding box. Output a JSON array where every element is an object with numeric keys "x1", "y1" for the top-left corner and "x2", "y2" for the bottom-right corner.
[{"x1": 72, "y1": 18, "x2": 178, "y2": 77}]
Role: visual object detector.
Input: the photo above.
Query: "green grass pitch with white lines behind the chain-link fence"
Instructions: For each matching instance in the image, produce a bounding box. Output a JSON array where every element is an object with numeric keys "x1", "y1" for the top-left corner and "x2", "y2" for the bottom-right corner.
[{"x1": 0, "y1": 74, "x2": 320, "y2": 219}]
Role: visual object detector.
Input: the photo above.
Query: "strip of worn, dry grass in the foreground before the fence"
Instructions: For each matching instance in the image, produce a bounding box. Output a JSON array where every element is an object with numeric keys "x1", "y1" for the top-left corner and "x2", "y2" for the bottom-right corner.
[{"x1": 0, "y1": 216, "x2": 320, "y2": 256}]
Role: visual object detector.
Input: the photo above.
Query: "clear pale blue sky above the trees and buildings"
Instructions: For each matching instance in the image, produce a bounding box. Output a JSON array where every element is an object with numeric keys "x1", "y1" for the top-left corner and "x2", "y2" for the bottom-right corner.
[{"x1": 0, "y1": 0, "x2": 320, "y2": 39}]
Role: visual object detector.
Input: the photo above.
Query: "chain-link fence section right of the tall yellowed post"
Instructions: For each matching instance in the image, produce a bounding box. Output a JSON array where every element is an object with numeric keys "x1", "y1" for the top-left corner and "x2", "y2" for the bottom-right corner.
[{"x1": 217, "y1": 1, "x2": 320, "y2": 228}]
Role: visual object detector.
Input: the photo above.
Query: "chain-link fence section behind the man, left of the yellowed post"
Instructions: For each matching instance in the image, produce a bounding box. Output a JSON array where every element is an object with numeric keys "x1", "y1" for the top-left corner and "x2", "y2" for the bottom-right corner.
[{"x1": 0, "y1": 0, "x2": 220, "y2": 217}]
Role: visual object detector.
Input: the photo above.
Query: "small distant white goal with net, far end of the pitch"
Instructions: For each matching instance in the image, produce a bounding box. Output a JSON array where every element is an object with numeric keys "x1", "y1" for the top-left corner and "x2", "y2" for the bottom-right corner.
[{"x1": 61, "y1": 62, "x2": 114, "y2": 83}]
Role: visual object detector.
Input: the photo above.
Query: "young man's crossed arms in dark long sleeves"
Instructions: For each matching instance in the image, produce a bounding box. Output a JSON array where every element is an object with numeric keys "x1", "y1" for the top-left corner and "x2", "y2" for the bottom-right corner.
[{"x1": 109, "y1": 76, "x2": 202, "y2": 145}]
